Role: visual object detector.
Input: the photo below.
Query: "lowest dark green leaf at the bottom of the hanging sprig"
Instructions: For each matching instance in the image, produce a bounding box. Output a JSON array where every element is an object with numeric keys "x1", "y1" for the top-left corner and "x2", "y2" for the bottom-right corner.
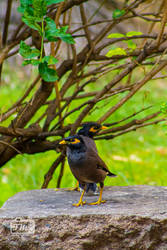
[{"x1": 38, "y1": 62, "x2": 58, "y2": 82}]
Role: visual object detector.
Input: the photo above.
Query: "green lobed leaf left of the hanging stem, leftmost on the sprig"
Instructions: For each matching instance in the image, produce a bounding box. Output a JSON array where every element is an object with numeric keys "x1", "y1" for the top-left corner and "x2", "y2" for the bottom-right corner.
[{"x1": 19, "y1": 41, "x2": 40, "y2": 59}]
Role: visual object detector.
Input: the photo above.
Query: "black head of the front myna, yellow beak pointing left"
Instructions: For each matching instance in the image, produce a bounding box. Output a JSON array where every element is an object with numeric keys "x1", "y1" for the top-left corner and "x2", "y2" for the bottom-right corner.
[{"x1": 59, "y1": 135, "x2": 85, "y2": 148}]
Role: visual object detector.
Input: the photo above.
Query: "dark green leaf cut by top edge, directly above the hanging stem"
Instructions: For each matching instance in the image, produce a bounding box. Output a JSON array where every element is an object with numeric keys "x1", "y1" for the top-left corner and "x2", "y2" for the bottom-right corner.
[{"x1": 32, "y1": 0, "x2": 47, "y2": 18}]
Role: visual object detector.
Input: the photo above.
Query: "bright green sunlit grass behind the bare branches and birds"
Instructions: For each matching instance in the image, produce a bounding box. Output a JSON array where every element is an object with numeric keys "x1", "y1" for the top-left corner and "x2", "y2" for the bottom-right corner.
[{"x1": 0, "y1": 63, "x2": 167, "y2": 205}]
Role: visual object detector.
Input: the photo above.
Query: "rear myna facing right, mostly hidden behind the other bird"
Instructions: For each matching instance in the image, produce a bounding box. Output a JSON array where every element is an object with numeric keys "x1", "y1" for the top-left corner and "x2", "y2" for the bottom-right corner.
[{"x1": 77, "y1": 122, "x2": 107, "y2": 194}]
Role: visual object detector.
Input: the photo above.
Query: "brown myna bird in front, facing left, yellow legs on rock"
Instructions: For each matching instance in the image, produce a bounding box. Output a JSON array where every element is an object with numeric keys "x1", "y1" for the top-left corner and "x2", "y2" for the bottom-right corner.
[{"x1": 59, "y1": 135, "x2": 116, "y2": 207}]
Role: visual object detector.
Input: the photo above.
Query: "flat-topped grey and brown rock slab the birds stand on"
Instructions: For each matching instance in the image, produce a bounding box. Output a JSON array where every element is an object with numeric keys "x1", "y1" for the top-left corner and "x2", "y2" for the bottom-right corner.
[{"x1": 0, "y1": 186, "x2": 167, "y2": 250}]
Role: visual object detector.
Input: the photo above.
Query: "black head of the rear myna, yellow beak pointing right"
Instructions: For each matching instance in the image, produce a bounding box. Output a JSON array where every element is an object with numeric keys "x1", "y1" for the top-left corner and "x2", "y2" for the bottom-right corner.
[{"x1": 77, "y1": 122, "x2": 107, "y2": 138}]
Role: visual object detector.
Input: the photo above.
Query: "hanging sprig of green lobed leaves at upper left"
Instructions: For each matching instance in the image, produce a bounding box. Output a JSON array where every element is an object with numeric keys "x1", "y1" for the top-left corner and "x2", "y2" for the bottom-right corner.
[{"x1": 18, "y1": 0, "x2": 74, "y2": 82}]
